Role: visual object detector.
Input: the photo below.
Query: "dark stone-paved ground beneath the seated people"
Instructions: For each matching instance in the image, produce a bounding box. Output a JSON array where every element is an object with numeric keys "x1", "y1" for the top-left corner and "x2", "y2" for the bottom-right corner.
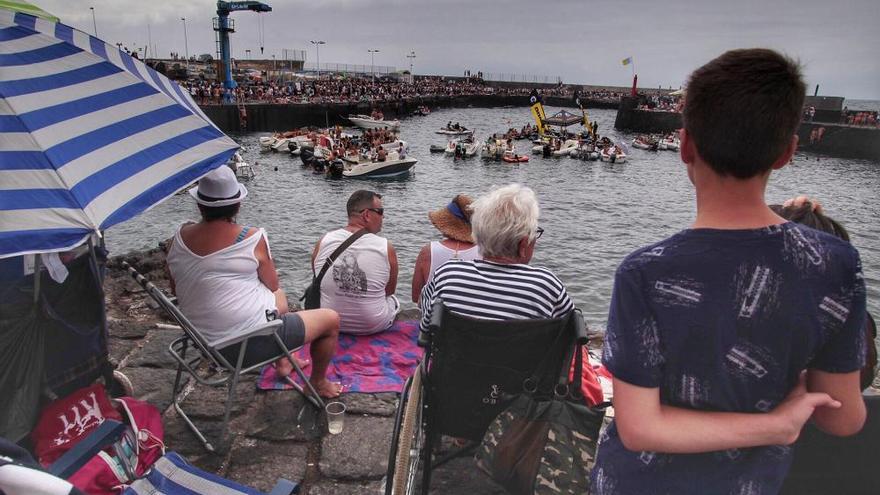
[{"x1": 104, "y1": 248, "x2": 504, "y2": 495}]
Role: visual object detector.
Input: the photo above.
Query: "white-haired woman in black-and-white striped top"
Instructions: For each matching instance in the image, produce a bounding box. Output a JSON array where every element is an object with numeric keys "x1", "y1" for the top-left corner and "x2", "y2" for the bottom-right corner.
[{"x1": 419, "y1": 184, "x2": 572, "y2": 331}]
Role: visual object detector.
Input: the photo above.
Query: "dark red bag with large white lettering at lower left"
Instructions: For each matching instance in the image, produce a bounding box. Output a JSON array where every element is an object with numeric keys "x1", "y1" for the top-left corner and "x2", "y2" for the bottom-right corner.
[{"x1": 31, "y1": 384, "x2": 122, "y2": 466}]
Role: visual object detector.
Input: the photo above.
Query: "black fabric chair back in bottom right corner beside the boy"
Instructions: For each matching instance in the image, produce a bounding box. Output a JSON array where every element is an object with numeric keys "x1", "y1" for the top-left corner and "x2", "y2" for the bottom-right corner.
[{"x1": 780, "y1": 395, "x2": 880, "y2": 495}]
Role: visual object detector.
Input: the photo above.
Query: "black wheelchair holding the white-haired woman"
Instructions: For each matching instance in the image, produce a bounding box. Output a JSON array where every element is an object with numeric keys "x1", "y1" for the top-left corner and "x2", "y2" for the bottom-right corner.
[{"x1": 385, "y1": 301, "x2": 587, "y2": 495}]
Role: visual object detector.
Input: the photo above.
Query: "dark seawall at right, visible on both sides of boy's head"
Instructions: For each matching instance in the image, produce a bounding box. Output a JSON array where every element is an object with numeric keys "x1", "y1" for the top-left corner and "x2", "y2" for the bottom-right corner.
[{"x1": 614, "y1": 97, "x2": 880, "y2": 161}]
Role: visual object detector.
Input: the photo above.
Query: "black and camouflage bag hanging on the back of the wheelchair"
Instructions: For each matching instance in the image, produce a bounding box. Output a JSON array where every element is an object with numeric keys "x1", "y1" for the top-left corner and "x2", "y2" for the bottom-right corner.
[{"x1": 475, "y1": 328, "x2": 610, "y2": 495}]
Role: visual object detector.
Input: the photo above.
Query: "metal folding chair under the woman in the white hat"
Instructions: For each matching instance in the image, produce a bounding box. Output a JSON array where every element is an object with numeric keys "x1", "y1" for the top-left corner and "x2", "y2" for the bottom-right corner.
[{"x1": 122, "y1": 261, "x2": 324, "y2": 452}]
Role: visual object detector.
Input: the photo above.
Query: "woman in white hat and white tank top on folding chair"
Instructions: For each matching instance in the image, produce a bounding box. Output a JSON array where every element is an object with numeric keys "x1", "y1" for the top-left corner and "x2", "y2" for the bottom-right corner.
[{"x1": 166, "y1": 166, "x2": 342, "y2": 398}]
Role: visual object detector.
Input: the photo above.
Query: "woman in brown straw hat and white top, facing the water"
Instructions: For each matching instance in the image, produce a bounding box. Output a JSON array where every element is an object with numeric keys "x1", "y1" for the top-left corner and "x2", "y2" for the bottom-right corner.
[{"x1": 412, "y1": 194, "x2": 481, "y2": 304}]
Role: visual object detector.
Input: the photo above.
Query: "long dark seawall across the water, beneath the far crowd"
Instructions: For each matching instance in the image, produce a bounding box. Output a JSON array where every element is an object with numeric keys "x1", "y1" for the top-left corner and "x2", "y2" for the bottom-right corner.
[{"x1": 201, "y1": 95, "x2": 617, "y2": 132}]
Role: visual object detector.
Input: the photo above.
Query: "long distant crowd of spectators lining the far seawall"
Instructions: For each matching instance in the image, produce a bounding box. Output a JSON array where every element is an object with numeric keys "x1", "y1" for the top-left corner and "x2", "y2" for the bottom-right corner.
[{"x1": 185, "y1": 77, "x2": 625, "y2": 105}]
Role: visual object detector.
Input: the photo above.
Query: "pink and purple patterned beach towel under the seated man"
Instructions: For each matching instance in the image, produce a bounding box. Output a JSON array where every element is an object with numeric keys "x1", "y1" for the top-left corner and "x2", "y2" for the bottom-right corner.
[{"x1": 257, "y1": 321, "x2": 423, "y2": 393}]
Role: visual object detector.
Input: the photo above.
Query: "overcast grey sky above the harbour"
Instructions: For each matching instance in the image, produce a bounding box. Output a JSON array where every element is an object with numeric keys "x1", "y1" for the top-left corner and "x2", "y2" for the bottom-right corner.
[{"x1": 31, "y1": 0, "x2": 880, "y2": 100}]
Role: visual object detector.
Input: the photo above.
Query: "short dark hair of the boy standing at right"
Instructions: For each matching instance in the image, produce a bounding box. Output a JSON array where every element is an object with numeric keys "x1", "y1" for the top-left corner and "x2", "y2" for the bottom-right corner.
[{"x1": 682, "y1": 48, "x2": 806, "y2": 179}]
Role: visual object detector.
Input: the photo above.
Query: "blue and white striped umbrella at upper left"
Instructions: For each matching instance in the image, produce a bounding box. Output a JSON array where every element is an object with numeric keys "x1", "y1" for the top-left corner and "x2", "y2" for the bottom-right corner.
[{"x1": 0, "y1": 10, "x2": 238, "y2": 258}]
